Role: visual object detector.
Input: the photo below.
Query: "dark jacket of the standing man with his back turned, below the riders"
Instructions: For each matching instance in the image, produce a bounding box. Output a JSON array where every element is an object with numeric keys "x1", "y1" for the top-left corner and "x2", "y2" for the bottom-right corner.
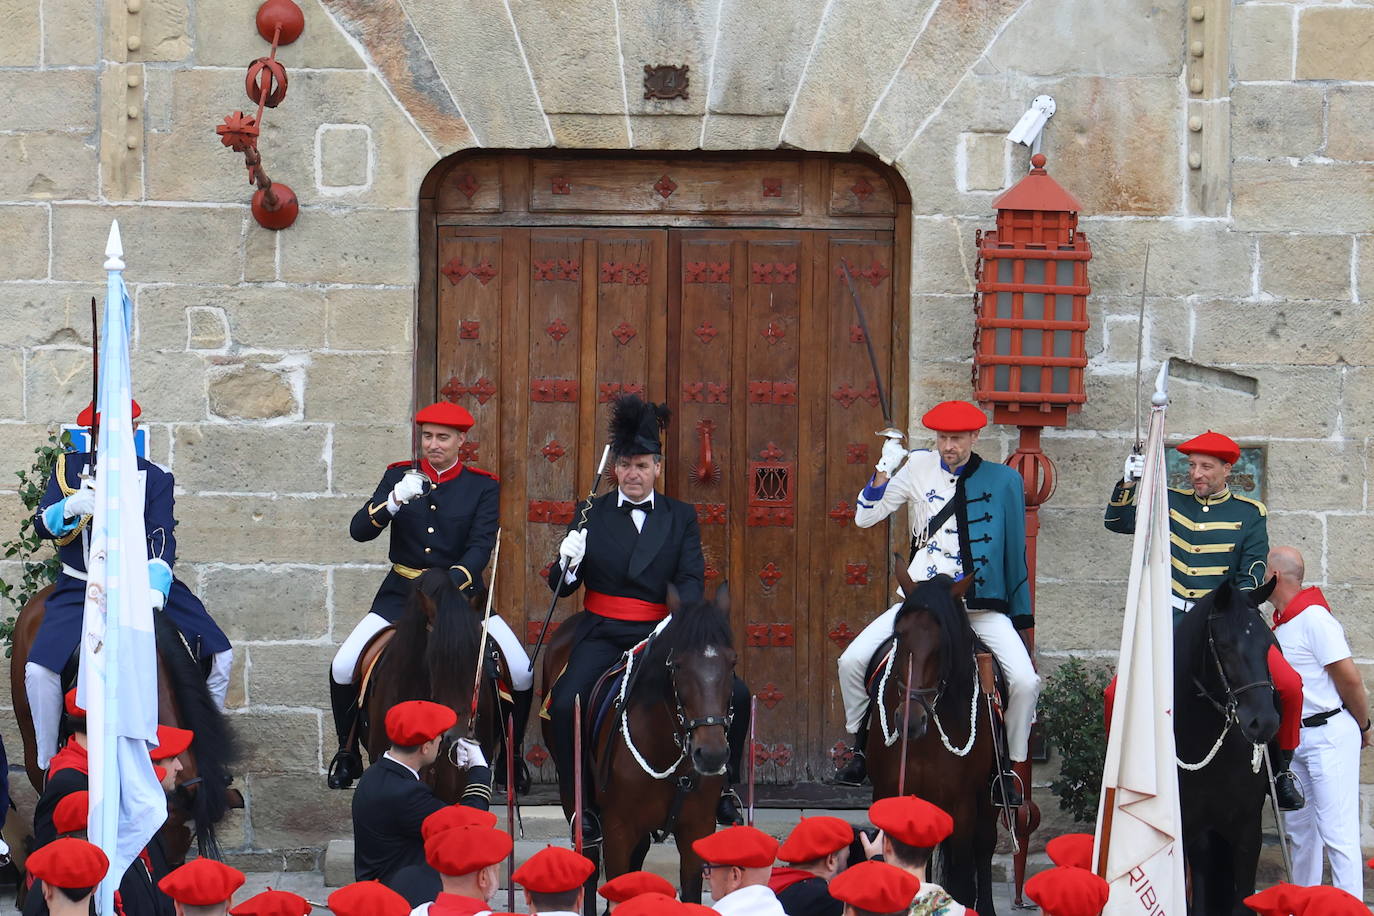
[{"x1": 353, "y1": 757, "x2": 444, "y2": 884}]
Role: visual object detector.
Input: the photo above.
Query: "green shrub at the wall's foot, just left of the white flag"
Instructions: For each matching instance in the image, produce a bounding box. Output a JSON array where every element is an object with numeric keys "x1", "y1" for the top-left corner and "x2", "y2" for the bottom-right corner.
[{"x1": 1040, "y1": 658, "x2": 1113, "y2": 823}]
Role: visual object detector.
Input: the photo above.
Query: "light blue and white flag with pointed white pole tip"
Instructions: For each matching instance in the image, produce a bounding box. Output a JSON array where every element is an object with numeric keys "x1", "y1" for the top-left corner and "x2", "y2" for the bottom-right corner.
[{"x1": 77, "y1": 222, "x2": 166, "y2": 916}]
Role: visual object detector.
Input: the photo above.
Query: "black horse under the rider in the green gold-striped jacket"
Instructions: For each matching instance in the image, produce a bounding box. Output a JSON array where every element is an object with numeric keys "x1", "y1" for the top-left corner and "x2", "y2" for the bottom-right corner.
[{"x1": 1173, "y1": 580, "x2": 1279, "y2": 916}]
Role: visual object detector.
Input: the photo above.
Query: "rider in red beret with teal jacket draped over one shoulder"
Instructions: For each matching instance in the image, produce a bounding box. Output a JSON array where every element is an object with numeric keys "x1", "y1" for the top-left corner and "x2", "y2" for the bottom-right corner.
[{"x1": 837, "y1": 401, "x2": 1040, "y2": 808}]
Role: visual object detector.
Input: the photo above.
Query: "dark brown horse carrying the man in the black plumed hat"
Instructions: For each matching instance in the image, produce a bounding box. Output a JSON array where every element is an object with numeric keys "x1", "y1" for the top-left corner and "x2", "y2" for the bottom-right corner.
[{"x1": 543, "y1": 584, "x2": 738, "y2": 913}]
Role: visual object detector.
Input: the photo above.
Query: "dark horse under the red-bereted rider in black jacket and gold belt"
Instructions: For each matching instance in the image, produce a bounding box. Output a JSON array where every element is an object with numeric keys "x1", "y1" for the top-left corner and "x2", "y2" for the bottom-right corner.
[{"x1": 354, "y1": 570, "x2": 504, "y2": 803}]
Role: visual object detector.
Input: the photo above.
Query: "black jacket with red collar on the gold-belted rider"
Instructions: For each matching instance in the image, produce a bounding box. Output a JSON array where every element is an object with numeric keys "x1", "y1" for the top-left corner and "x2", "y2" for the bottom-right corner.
[{"x1": 349, "y1": 461, "x2": 500, "y2": 622}]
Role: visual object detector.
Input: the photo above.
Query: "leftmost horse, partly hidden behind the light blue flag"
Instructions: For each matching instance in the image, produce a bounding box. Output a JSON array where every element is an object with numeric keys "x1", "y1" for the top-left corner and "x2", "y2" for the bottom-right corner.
[{"x1": 10, "y1": 585, "x2": 243, "y2": 867}]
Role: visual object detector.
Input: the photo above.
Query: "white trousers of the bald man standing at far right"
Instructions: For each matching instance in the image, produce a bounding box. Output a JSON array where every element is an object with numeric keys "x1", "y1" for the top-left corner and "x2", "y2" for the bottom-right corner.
[{"x1": 1283, "y1": 713, "x2": 1364, "y2": 900}]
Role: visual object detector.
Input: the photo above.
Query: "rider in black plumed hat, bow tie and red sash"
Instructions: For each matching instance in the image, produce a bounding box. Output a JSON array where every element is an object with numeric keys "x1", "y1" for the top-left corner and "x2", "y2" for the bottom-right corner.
[{"x1": 548, "y1": 394, "x2": 749, "y2": 843}]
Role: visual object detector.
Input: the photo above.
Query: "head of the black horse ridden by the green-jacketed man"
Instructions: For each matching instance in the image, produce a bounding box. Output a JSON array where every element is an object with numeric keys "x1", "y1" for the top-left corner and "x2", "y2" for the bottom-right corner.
[{"x1": 1187, "y1": 580, "x2": 1279, "y2": 744}]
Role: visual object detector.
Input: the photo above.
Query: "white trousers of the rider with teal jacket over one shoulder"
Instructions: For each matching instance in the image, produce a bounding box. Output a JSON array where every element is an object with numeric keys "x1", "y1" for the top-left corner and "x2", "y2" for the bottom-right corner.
[{"x1": 840, "y1": 604, "x2": 1040, "y2": 762}]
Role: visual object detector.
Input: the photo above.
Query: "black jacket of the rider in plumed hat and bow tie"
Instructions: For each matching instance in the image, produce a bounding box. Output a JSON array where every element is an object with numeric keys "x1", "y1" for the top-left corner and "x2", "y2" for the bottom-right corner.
[{"x1": 548, "y1": 490, "x2": 706, "y2": 604}]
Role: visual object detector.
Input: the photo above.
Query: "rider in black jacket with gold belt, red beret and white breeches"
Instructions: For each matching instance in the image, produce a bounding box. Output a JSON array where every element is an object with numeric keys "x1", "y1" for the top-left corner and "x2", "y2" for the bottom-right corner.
[{"x1": 328, "y1": 401, "x2": 534, "y2": 791}]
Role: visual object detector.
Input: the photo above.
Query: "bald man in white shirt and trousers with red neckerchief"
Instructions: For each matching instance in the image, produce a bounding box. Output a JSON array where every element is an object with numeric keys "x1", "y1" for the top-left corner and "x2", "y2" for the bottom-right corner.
[{"x1": 1268, "y1": 547, "x2": 1370, "y2": 897}]
